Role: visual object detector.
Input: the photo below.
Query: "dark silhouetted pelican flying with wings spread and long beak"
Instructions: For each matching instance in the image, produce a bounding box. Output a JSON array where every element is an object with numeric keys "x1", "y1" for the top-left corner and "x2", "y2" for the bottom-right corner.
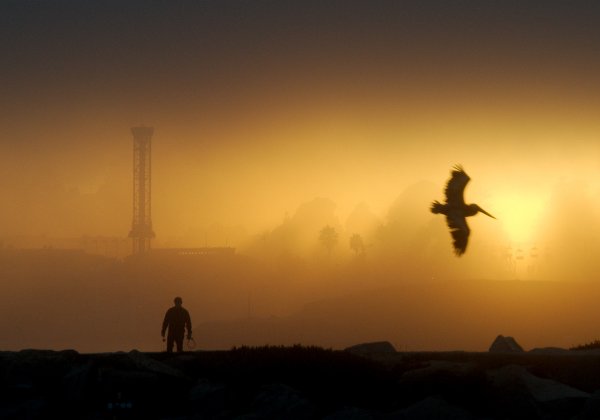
[{"x1": 431, "y1": 165, "x2": 495, "y2": 257}]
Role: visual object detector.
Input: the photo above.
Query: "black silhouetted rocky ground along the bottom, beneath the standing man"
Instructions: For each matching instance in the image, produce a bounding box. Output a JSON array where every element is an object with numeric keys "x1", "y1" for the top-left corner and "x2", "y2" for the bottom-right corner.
[{"x1": 0, "y1": 347, "x2": 600, "y2": 419}]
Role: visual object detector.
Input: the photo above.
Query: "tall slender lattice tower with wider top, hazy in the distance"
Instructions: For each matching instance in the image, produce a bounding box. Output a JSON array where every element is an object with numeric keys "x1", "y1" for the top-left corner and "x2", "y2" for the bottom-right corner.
[{"x1": 129, "y1": 127, "x2": 155, "y2": 254}]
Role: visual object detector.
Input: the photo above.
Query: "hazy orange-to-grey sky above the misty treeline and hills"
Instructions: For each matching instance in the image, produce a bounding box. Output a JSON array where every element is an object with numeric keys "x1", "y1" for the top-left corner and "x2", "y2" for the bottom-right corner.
[{"x1": 0, "y1": 0, "x2": 600, "y2": 246}]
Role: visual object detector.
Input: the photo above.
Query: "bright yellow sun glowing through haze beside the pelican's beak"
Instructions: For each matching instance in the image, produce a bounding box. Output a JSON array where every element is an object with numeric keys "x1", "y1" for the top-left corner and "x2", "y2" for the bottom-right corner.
[{"x1": 490, "y1": 192, "x2": 545, "y2": 244}]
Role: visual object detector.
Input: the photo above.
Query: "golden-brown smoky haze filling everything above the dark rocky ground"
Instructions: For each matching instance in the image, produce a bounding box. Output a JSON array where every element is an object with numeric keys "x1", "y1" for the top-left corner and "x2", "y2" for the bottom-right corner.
[{"x1": 0, "y1": 1, "x2": 600, "y2": 351}]
